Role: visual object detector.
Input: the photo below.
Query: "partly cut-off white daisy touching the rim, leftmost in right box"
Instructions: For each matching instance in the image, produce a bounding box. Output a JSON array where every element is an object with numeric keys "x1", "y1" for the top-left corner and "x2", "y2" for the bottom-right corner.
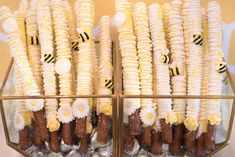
[{"x1": 123, "y1": 99, "x2": 140, "y2": 115}]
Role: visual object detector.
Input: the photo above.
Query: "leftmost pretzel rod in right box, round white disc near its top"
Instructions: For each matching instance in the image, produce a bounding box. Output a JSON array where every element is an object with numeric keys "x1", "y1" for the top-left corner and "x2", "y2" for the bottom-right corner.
[{"x1": 114, "y1": 0, "x2": 141, "y2": 152}]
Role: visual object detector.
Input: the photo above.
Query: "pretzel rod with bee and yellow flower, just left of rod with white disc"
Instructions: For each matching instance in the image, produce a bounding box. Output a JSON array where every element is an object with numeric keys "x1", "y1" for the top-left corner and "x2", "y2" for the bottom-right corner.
[{"x1": 37, "y1": 0, "x2": 60, "y2": 148}]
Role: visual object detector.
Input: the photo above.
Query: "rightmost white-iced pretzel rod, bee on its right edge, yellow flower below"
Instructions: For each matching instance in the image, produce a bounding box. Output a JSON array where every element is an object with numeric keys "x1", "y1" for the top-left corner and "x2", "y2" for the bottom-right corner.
[{"x1": 205, "y1": 1, "x2": 224, "y2": 151}]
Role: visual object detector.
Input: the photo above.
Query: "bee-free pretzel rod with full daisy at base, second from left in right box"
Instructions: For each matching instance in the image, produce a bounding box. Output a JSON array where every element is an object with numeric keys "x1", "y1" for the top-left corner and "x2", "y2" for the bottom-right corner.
[{"x1": 133, "y1": 2, "x2": 156, "y2": 147}]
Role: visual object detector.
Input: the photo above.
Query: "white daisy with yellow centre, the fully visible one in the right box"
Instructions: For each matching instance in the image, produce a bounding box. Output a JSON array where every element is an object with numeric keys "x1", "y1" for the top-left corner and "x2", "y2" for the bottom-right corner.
[{"x1": 140, "y1": 107, "x2": 156, "y2": 126}]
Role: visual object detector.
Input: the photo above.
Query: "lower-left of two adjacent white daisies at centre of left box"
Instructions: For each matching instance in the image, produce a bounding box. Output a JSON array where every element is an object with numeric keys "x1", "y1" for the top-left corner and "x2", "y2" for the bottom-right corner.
[{"x1": 57, "y1": 105, "x2": 74, "y2": 123}]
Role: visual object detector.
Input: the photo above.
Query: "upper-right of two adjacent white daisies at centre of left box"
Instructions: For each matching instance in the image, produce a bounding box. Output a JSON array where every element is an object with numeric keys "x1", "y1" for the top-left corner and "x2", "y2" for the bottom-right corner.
[{"x1": 73, "y1": 99, "x2": 90, "y2": 118}]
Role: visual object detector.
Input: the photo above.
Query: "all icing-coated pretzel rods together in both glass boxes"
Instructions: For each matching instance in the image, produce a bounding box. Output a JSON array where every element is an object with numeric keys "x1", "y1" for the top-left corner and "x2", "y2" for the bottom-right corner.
[{"x1": 0, "y1": 0, "x2": 227, "y2": 157}]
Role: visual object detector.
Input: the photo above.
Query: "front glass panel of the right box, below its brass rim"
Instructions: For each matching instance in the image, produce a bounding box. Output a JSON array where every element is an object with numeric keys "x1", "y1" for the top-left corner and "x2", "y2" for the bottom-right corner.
[{"x1": 121, "y1": 98, "x2": 233, "y2": 157}]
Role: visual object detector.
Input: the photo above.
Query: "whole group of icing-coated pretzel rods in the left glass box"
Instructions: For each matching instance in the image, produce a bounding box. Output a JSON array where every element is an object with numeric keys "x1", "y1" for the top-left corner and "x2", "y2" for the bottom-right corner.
[{"x1": 0, "y1": 0, "x2": 114, "y2": 155}]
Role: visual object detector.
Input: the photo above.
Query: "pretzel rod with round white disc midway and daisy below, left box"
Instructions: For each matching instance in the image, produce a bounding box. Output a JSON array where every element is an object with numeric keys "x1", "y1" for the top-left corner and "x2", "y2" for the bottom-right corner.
[{"x1": 51, "y1": 0, "x2": 73, "y2": 144}]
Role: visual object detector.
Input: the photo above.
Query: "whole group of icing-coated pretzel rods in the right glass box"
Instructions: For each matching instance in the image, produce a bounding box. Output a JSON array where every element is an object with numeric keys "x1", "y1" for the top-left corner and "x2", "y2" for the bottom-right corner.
[{"x1": 114, "y1": 0, "x2": 226, "y2": 157}]
